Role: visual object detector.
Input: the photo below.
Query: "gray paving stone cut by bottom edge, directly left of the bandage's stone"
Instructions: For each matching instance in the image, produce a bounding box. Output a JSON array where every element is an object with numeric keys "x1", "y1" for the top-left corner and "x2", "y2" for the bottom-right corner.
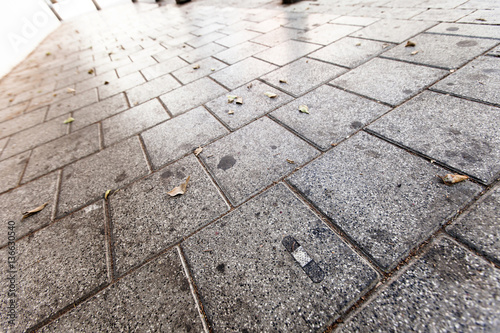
[{"x1": 40, "y1": 250, "x2": 203, "y2": 332}]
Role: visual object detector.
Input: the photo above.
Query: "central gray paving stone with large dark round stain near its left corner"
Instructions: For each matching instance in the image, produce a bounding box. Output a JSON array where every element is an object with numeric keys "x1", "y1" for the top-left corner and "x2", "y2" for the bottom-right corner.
[{"x1": 200, "y1": 118, "x2": 319, "y2": 205}]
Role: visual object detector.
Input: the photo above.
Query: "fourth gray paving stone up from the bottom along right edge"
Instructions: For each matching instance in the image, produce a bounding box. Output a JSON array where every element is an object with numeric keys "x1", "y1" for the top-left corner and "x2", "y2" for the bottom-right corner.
[{"x1": 432, "y1": 57, "x2": 500, "y2": 106}]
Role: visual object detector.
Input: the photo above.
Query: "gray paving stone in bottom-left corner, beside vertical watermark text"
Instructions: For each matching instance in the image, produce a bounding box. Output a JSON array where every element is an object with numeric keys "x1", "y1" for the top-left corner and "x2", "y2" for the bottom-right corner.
[{"x1": 0, "y1": 202, "x2": 107, "y2": 332}]
